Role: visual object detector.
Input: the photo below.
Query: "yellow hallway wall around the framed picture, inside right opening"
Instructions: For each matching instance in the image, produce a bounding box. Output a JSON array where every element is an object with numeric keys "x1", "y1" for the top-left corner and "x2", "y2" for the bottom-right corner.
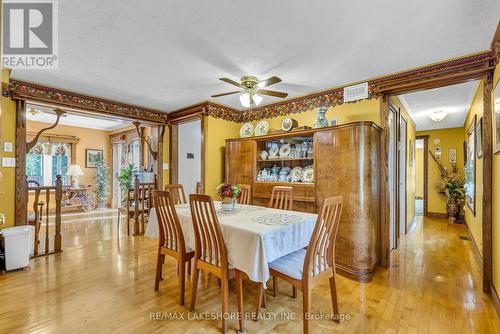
[{"x1": 463, "y1": 82, "x2": 484, "y2": 254}]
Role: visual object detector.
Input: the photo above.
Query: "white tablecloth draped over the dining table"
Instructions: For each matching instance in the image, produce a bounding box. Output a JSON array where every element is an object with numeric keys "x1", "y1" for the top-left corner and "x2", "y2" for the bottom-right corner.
[{"x1": 145, "y1": 202, "x2": 317, "y2": 286}]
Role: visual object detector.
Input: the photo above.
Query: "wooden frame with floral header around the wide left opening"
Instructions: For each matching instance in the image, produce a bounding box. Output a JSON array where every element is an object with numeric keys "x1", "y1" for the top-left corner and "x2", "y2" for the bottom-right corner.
[{"x1": 9, "y1": 80, "x2": 167, "y2": 225}]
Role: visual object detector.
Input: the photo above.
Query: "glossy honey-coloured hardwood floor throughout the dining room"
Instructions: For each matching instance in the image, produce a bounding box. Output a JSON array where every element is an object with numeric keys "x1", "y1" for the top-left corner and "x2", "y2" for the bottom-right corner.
[{"x1": 0, "y1": 218, "x2": 500, "y2": 334}]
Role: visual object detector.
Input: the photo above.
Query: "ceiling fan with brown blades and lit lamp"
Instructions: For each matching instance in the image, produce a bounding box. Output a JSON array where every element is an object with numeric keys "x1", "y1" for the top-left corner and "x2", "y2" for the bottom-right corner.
[{"x1": 212, "y1": 76, "x2": 288, "y2": 108}]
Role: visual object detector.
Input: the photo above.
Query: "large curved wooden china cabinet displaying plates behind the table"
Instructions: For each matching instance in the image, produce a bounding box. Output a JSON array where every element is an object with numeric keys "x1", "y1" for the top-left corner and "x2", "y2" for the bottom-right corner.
[{"x1": 225, "y1": 122, "x2": 381, "y2": 281}]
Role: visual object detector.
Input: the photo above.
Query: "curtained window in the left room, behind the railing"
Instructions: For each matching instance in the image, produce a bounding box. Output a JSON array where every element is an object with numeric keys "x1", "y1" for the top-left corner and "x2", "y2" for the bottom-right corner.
[{"x1": 26, "y1": 142, "x2": 71, "y2": 186}]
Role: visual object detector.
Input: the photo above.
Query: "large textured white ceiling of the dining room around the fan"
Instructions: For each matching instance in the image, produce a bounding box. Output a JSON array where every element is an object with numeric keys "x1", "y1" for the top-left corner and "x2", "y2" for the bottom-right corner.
[{"x1": 13, "y1": 0, "x2": 500, "y2": 111}]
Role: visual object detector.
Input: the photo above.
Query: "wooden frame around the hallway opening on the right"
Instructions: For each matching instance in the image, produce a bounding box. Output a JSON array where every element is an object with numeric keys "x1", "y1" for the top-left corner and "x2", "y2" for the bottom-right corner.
[{"x1": 376, "y1": 49, "x2": 500, "y2": 293}]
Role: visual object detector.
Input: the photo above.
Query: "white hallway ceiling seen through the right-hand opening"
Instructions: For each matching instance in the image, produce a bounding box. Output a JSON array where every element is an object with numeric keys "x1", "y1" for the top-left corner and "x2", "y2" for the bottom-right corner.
[{"x1": 398, "y1": 81, "x2": 479, "y2": 131}]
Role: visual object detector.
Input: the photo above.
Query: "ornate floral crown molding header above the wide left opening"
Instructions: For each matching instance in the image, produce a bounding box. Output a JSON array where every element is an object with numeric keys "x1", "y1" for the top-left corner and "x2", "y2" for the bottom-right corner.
[{"x1": 8, "y1": 80, "x2": 167, "y2": 123}]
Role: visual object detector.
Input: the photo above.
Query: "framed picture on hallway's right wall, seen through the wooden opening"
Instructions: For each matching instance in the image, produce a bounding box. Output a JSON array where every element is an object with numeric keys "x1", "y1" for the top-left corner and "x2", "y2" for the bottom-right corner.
[{"x1": 464, "y1": 115, "x2": 476, "y2": 216}]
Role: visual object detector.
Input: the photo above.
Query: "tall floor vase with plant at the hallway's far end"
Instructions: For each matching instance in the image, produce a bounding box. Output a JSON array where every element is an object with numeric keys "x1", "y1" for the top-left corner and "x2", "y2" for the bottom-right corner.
[{"x1": 439, "y1": 168, "x2": 465, "y2": 220}]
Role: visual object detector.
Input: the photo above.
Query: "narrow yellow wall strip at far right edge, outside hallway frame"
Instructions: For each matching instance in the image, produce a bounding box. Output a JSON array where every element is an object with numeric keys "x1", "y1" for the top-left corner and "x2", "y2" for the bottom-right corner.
[{"x1": 492, "y1": 65, "x2": 500, "y2": 292}]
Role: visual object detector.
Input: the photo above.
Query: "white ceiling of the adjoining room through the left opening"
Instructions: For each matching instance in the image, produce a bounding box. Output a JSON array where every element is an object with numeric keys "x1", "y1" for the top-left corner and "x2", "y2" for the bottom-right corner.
[{"x1": 26, "y1": 104, "x2": 132, "y2": 132}]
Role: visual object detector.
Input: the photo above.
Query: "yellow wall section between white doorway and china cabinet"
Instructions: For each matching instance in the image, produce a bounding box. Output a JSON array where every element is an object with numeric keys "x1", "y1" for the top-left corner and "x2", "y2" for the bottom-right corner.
[{"x1": 204, "y1": 117, "x2": 241, "y2": 199}]
